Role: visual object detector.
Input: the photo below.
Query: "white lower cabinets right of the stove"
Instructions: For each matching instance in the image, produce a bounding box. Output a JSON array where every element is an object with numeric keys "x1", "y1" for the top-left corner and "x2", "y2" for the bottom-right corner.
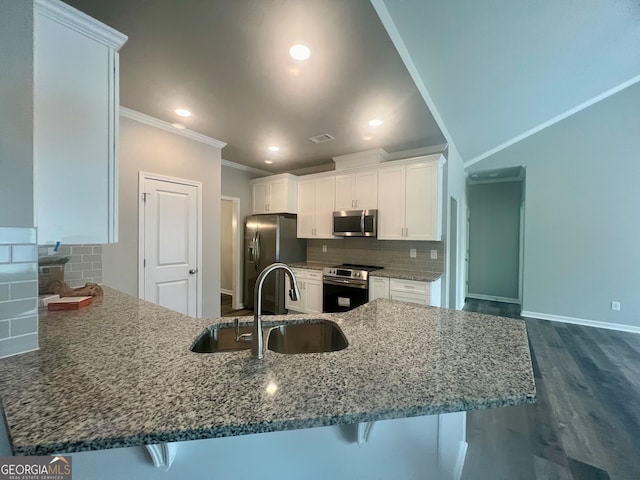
[{"x1": 369, "y1": 277, "x2": 440, "y2": 307}]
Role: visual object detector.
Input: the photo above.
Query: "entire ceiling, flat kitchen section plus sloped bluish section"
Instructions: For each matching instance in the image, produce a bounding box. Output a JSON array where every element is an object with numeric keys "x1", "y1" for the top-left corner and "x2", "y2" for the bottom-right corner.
[{"x1": 66, "y1": 0, "x2": 640, "y2": 173}]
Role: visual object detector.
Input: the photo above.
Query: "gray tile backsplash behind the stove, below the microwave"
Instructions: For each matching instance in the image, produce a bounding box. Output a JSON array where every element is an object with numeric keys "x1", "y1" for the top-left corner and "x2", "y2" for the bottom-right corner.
[{"x1": 307, "y1": 238, "x2": 445, "y2": 273}]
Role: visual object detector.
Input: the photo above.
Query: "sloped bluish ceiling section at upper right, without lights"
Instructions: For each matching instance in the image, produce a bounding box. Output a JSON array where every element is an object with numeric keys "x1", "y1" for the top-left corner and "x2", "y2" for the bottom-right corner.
[{"x1": 372, "y1": 0, "x2": 640, "y2": 164}]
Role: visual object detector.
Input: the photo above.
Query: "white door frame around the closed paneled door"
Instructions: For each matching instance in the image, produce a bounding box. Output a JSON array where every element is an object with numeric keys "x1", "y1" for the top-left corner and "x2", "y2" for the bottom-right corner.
[{"x1": 138, "y1": 171, "x2": 203, "y2": 318}]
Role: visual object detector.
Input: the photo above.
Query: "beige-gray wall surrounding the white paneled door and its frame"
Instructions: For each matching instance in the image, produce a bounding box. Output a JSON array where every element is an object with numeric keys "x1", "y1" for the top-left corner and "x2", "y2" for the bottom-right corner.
[{"x1": 102, "y1": 117, "x2": 220, "y2": 317}]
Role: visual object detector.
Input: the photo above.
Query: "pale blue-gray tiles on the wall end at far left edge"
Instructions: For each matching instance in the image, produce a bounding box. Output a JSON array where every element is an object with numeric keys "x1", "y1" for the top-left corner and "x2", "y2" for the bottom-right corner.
[{"x1": 0, "y1": 227, "x2": 38, "y2": 358}]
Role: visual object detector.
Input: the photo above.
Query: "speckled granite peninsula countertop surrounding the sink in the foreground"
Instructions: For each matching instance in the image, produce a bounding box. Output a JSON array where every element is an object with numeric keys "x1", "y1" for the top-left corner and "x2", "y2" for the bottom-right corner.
[{"x1": 0, "y1": 288, "x2": 536, "y2": 455}]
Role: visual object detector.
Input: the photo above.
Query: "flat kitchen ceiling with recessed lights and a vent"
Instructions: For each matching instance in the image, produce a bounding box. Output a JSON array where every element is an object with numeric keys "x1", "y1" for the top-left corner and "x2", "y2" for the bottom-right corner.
[{"x1": 66, "y1": 0, "x2": 444, "y2": 173}]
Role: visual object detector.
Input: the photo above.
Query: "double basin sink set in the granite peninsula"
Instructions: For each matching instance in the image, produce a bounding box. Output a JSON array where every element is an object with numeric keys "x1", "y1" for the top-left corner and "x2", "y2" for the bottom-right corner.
[{"x1": 191, "y1": 319, "x2": 349, "y2": 354}]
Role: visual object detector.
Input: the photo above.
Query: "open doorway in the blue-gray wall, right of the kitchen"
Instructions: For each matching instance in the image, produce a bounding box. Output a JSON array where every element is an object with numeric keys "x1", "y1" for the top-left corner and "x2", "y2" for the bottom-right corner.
[{"x1": 465, "y1": 167, "x2": 525, "y2": 305}]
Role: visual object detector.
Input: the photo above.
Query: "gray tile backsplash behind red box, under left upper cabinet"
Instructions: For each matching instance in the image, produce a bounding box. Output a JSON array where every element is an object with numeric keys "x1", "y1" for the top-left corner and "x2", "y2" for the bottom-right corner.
[{"x1": 38, "y1": 245, "x2": 102, "y2": 287}]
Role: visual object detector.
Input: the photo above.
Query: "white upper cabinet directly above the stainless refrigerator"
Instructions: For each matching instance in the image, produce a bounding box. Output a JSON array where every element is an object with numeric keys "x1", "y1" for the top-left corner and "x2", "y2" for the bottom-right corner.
[{"x1": 252, "y1": 173, "x2": 298, "y2": 214}]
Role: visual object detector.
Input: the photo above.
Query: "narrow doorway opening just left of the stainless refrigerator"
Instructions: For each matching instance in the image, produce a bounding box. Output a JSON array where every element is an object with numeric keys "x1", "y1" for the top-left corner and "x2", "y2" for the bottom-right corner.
[{"x1": 220, "y1": 196, "x2": 244, "y2": 310}]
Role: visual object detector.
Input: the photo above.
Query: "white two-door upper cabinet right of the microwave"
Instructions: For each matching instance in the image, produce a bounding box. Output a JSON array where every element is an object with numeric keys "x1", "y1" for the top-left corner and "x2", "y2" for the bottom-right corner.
[{"x1": 378, "y1": 155, "x2": 444, "y2": 240}]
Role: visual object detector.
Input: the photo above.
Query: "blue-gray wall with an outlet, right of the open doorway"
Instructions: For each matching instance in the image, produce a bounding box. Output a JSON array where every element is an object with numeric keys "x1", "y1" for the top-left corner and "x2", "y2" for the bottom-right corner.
[{"x1": 469, "y1": 84, "x2": 640, "y2": 327}]
